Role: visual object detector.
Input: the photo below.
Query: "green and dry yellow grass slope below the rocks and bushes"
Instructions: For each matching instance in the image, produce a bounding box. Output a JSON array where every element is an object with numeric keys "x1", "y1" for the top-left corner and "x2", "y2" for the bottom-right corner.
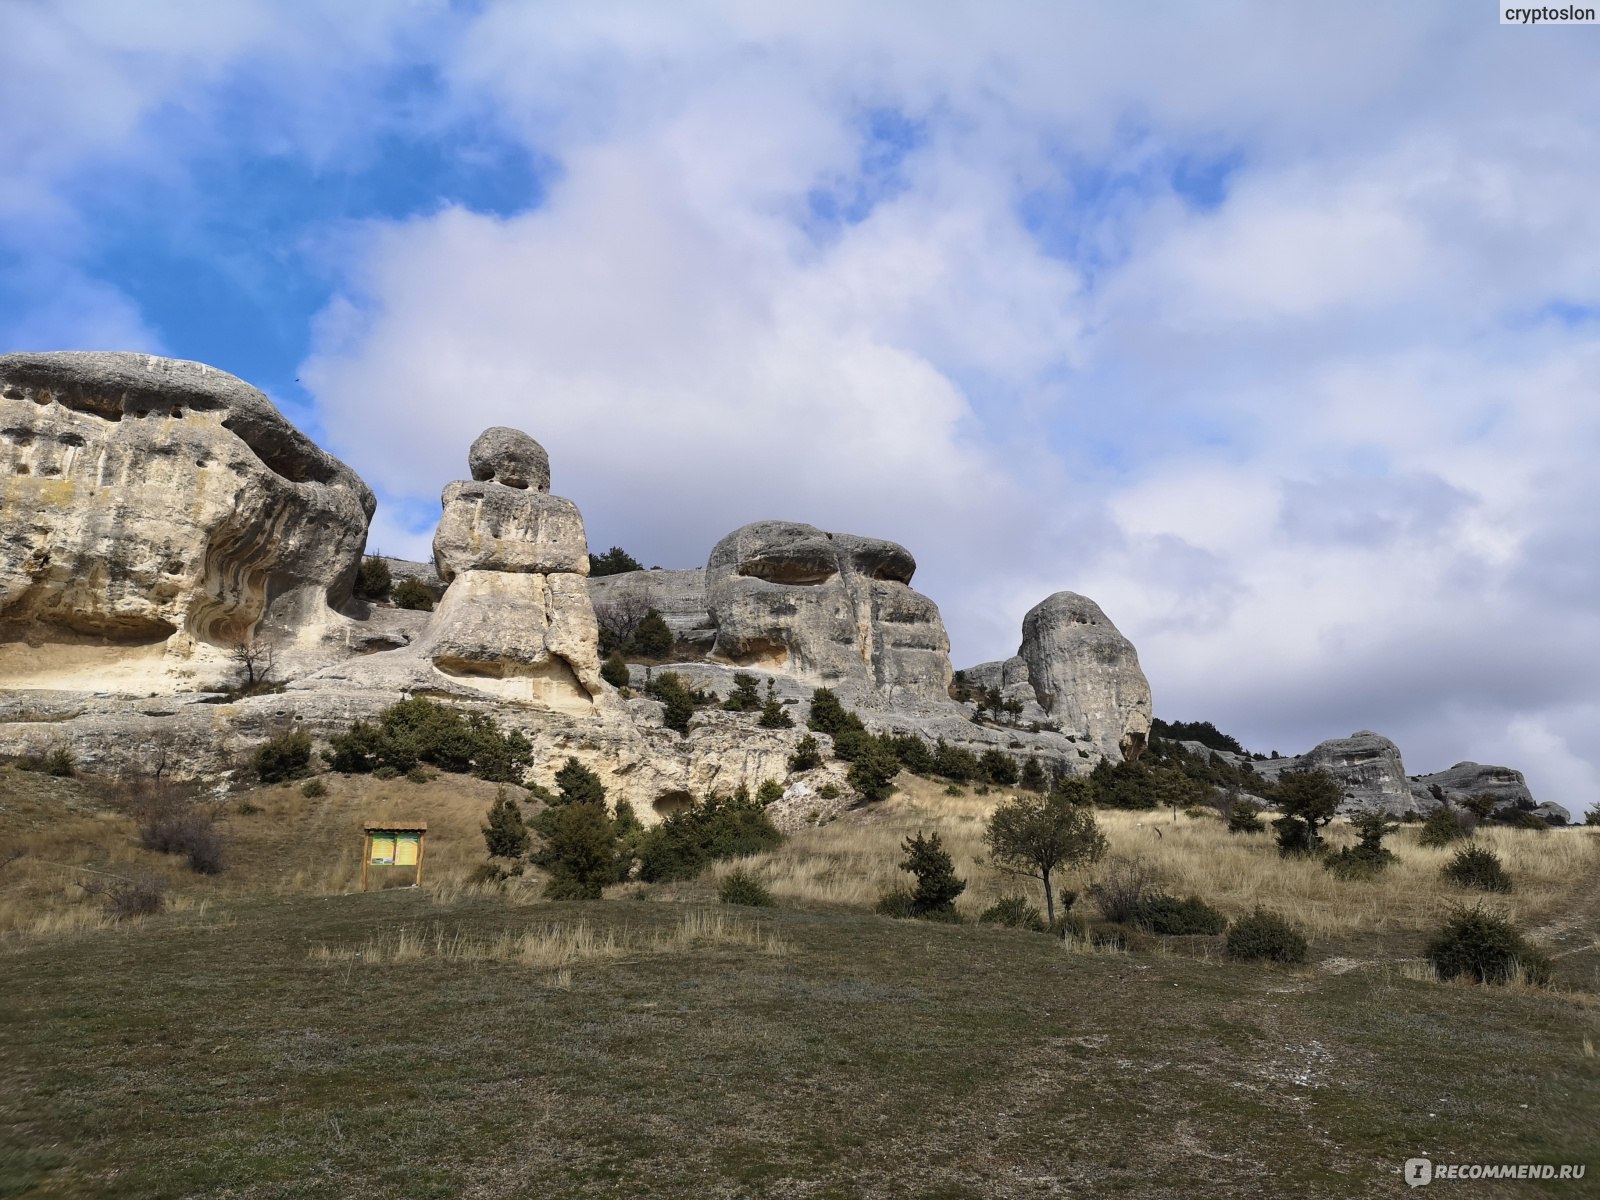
[{"x1": 0, "y1": 771, "x2": 1600, "y2": 1197}]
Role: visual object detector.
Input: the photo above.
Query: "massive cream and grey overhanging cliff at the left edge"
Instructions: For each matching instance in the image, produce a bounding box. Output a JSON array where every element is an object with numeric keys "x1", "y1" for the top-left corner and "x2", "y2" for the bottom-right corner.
[{"x1": 0, "y1": 352, "x2": 374, "y2": 686}]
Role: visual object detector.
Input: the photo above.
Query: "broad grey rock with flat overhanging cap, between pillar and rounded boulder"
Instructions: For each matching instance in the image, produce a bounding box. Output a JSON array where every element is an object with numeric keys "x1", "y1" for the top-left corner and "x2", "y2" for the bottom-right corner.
[{"x1": 706, "y1": 522, "x2": 950, "y2": 706}]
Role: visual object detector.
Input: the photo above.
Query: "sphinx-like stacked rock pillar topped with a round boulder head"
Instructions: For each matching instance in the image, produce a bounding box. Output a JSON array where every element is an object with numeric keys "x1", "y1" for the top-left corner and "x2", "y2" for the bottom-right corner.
[{"x1": 418, "y1": 429, "x2": 605, "y2": 712}]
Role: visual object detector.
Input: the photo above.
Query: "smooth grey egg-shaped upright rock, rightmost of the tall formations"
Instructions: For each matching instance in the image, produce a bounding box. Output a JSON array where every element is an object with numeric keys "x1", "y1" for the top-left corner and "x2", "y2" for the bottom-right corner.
[{"x1": 1018, "y1": 592, "x2": 1152, "y2": 760}]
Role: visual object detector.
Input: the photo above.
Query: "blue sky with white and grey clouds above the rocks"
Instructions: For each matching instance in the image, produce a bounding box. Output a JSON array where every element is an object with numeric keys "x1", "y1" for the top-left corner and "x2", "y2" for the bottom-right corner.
[{"x1": 0, "y1": 0, "x2": 1600, "y2": 810}]
